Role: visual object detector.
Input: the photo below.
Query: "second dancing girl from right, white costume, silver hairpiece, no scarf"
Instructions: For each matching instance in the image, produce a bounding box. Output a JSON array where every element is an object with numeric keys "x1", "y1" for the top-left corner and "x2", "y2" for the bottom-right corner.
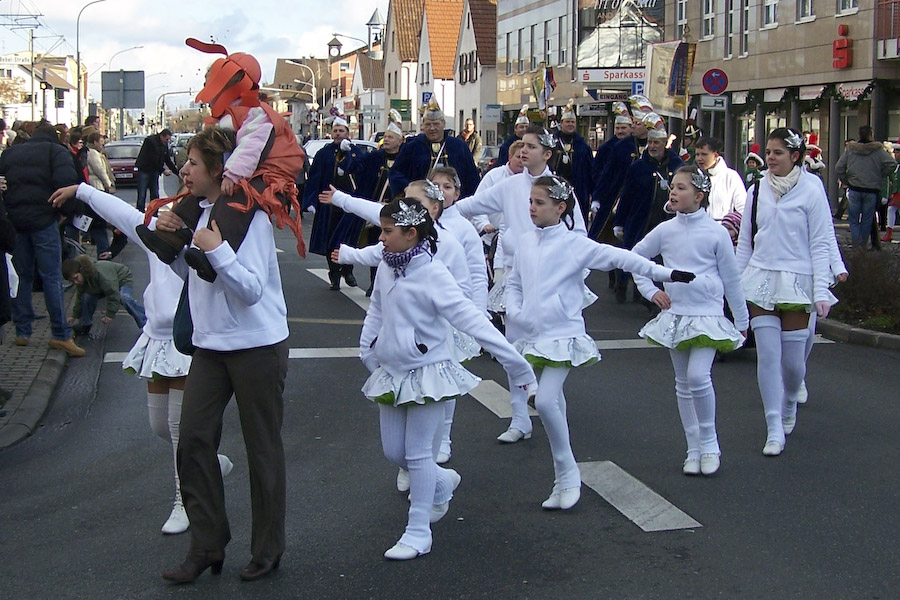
[{"x1": 632, "y1": 165, "x2": 750, "y2": 475}]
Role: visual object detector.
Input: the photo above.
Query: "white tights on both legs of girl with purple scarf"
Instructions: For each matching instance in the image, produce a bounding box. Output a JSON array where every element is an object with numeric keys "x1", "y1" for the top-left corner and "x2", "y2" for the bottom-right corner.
[{"x1": 379, "y1": 402, "x2": 453, "y2": 552}]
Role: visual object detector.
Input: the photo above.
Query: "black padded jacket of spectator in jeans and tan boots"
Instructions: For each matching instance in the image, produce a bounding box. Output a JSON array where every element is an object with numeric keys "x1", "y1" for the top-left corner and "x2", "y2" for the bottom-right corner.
[{"x1": 0, "y1": 132, "x2": 78, "y2": 232}]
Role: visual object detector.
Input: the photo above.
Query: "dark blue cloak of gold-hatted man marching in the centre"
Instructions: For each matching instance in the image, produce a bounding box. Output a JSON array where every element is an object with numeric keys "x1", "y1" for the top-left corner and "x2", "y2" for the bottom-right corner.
[{"x1": 390, "y1": 129, "x2": 481, "y2": 198}]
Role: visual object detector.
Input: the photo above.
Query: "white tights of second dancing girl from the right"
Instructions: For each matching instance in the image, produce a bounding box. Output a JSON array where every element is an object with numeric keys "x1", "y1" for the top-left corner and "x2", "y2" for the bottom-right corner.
[{"x1": 669, "y1": 348, "x2": 720, "y2": 460}]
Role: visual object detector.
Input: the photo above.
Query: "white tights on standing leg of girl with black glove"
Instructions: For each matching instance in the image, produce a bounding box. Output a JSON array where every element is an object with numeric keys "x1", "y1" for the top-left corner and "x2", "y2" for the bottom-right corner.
[{"x1": 534, "y1": 367, "x2": 581, "y2": 492}]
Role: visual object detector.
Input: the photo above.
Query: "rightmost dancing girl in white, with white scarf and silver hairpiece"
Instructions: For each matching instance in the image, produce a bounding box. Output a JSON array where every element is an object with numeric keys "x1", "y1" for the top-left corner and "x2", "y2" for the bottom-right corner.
[{"x1": 737, "y1": 127, "x2": 837, "y2": 456}]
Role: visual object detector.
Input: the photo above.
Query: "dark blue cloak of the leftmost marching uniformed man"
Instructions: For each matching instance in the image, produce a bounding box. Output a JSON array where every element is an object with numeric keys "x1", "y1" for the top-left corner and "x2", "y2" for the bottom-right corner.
[{"x1": 303, "y1": 144, "x2": 363, "y2": 256}]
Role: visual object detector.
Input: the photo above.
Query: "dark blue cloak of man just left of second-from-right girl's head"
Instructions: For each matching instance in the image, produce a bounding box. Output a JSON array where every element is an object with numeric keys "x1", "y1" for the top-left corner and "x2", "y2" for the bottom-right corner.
[{"x1": 614, "y1": 150, "x2": 683, "y2": 249}]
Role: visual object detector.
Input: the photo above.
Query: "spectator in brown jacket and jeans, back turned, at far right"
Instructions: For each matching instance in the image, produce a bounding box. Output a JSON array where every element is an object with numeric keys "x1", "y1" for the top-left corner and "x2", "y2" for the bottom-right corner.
[{"x1": 835, "y1": 125, "x2": 897, "y2": 250}]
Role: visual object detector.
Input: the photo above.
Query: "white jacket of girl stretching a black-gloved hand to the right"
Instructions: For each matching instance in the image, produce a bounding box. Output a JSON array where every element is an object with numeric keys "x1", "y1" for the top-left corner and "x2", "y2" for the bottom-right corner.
[{"x1": 506, "y1": 221, "x2": 672, "y2": 340}]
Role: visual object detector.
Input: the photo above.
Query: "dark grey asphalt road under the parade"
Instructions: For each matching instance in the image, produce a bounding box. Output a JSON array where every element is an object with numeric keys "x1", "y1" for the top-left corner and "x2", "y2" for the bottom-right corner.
[{"x1": 0, "y1": 190, "x2": 900, "y2": 599}]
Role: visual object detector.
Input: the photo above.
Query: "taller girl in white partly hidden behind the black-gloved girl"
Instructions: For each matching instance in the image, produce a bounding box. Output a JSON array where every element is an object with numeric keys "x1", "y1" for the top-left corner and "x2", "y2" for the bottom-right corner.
[{"x1": 447, "y1": 125, "x2": 596, "y2": 443}]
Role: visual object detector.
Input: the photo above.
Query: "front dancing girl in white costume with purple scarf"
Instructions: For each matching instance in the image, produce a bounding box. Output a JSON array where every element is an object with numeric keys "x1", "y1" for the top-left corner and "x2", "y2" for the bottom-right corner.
[{"x1": 360, "y1": 199, "x2": 537, "y2": 560}]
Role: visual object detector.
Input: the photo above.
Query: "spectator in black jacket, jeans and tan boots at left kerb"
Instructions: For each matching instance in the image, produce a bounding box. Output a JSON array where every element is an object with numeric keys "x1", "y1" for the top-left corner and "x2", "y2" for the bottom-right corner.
[{"x1": 0, "y1": 123, "x2": 84, "y2": 356}]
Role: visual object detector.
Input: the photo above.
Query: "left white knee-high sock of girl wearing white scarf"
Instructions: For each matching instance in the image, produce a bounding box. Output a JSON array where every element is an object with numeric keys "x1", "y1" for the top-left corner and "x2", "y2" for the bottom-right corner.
[{"x1": 750, "y1": 315, "x2": 784, "y2": 444}]
